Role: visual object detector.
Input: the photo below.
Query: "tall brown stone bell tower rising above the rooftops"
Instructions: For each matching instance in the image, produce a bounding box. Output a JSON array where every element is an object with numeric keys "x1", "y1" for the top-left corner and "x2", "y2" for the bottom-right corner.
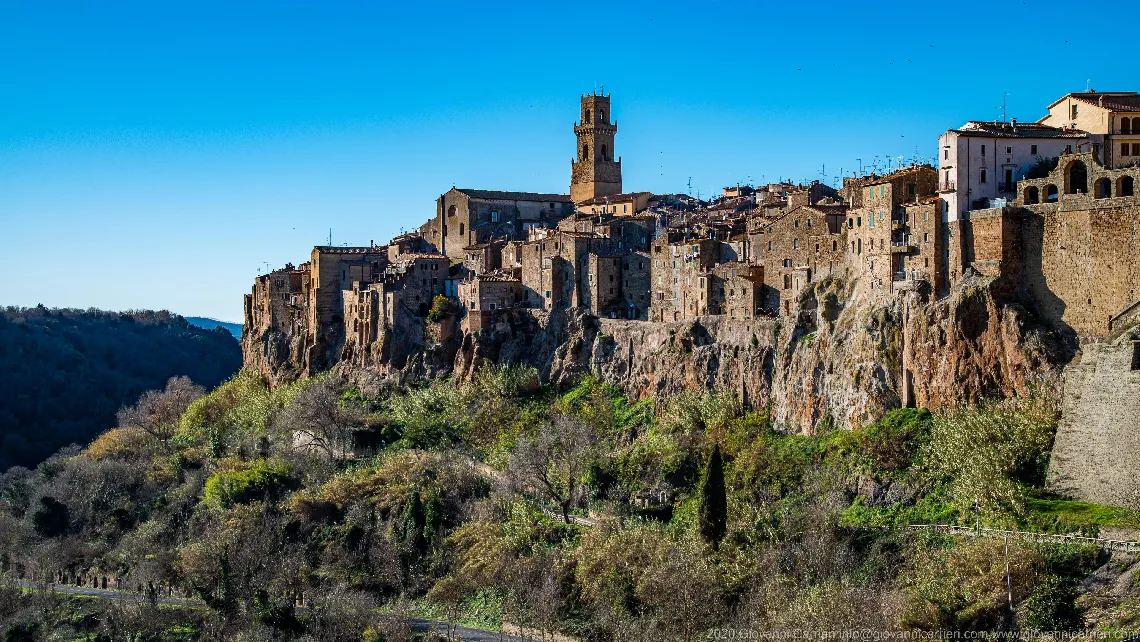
[{"x1": 570, "y1": 92, "x2": 621, "y2": 203}]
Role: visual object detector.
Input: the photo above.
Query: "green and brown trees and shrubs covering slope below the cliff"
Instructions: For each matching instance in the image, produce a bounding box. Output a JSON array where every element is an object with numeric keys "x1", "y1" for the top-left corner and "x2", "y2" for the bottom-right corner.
[{"x1": 0, "y1": 366, "x2": 1140, "y2": 642}]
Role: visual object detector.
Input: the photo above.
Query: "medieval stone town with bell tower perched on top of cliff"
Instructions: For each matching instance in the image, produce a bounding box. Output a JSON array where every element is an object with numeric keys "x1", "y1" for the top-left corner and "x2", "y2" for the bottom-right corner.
[{"x1": 244, "y1": 91, "x2": 1140, "y2": 380}]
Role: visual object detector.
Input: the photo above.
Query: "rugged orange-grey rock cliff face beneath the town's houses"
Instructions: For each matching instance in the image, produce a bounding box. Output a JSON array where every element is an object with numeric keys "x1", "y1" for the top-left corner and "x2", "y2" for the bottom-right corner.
[{"x1": 247, "y1": 273, "x2": 1067, "y2": 432}]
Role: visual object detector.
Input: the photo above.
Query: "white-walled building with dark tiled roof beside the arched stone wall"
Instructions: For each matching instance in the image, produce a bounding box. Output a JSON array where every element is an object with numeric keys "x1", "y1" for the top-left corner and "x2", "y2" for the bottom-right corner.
[{"x1": 938, "y1": 120, "x2": 1099, "y2": 222}]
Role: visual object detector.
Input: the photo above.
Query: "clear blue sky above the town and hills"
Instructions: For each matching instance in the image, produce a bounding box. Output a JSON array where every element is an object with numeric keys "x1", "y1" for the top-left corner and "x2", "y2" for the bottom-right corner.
[{"x1": 0, "y1": 0, "x2": 1140, "y2": 320}]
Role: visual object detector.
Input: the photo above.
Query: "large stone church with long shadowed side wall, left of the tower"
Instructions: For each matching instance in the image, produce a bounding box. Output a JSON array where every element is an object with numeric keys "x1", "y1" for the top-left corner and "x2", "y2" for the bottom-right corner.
[{"x1": 420, "y1": 187, "x2": 573, "y2": 260}]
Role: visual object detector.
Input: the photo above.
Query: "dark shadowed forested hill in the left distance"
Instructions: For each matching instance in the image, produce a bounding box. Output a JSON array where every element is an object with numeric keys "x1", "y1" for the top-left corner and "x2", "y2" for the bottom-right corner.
[{"x1": 0, "y1": 307, "x2": 242, "y2": 471}]
